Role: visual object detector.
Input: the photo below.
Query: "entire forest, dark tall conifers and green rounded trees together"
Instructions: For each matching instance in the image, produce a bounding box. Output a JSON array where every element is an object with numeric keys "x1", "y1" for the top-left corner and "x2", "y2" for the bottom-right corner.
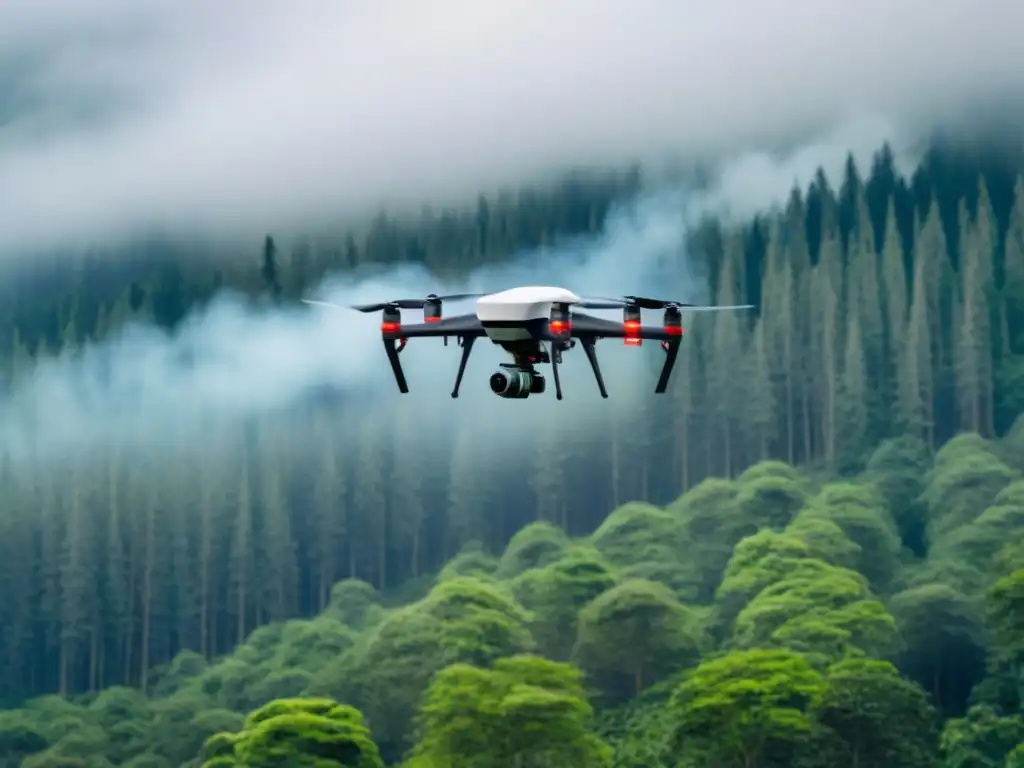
[{"x1": 0, "y1": 135, "x2": 1024, "y2": 768}]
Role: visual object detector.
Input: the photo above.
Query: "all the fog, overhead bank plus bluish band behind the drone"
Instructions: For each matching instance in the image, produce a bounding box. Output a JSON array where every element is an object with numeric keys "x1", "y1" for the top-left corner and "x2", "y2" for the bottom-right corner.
[{"x1": 0, "y1": 0, "x2": 1024, "y2": 475}]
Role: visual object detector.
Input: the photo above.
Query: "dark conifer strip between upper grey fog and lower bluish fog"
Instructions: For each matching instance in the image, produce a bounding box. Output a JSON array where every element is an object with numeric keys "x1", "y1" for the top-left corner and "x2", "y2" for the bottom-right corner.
[{"x1": 0, "y1": 170, "x2": 640, "y2": 356}]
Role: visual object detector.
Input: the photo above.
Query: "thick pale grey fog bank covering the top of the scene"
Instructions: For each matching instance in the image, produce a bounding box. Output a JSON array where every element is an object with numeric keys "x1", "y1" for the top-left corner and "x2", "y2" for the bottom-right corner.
[{"x1": 0, "y1": 0, "x2": 1024, "y2": 249}]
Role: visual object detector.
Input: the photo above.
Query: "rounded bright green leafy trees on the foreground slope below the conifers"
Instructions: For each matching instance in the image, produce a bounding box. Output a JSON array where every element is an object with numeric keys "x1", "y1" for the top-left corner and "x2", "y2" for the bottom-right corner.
[{"x1": 0, "y1": 436, "x2": 1024, "y2": 768}]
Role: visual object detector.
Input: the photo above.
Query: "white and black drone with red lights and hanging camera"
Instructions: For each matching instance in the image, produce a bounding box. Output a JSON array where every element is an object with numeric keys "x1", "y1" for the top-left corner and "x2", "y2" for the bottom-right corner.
[{"x1": 303, "y1": 286, "x2": 754, "y2": 400}]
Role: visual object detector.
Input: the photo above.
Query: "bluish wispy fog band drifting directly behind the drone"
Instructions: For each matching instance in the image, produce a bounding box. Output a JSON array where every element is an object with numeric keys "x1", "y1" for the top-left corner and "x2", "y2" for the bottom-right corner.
[{"x1": 0, "y1": 126, "x2": 912, "y2": 466}]
